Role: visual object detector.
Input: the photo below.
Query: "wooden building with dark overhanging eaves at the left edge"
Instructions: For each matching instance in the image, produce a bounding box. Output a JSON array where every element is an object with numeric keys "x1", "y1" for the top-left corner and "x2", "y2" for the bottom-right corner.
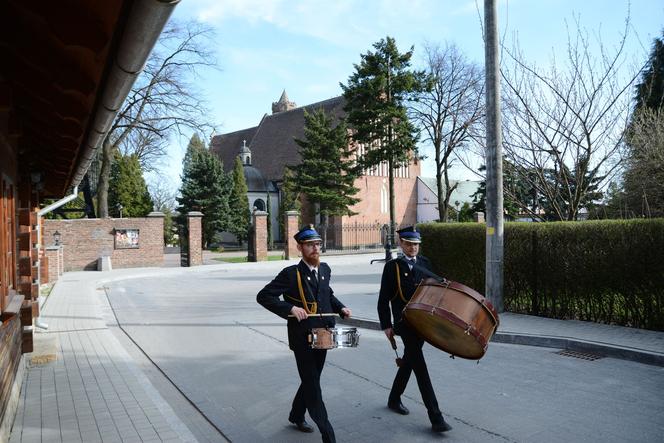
[{"x1": 0, "y1": 0, "x2": 179, "y2": 441}]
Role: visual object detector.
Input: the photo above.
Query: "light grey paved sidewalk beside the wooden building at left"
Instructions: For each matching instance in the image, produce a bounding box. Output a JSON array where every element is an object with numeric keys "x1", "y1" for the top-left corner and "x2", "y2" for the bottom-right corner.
[{"x1": 10, "y1": 270, "x2": 210, "y2": 443}]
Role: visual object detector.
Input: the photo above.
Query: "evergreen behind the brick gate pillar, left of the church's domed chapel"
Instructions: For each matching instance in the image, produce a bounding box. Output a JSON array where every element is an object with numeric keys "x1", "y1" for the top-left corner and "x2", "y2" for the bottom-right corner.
[{"x1": 177, "y1": 134, "x2": 232, "y2": 247}]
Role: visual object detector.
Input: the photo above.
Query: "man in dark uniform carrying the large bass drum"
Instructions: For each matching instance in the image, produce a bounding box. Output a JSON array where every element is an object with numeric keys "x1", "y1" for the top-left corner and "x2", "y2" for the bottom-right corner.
[{"x1": 378, "y1": 226, "x2": 452, "y2": 432}]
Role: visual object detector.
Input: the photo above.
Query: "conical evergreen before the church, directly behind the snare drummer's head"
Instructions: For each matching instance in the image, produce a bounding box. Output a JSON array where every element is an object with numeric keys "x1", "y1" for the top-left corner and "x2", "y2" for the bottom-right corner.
[{"x1": 293, "y1": 109, "x2": 359, "y2": 246}]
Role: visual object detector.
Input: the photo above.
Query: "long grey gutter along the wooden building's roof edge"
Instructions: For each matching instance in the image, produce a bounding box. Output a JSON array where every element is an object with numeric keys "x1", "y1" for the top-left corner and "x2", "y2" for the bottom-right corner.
[{"x1": 71, "y1": 0, "x2": 180, "y2": 186}]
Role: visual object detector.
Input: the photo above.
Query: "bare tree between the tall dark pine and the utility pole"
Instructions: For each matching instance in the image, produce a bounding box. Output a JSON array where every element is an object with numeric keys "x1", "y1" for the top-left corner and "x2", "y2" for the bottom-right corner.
[{"x1": 409, "y1": 44, "x2": 484, "y2": 222}]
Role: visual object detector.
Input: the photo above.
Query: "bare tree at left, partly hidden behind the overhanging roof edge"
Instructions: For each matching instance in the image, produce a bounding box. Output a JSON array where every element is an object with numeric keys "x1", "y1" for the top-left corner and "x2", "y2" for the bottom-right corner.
[{"x1": 97, "y1": 21, "x2": 216, "y2": 218}]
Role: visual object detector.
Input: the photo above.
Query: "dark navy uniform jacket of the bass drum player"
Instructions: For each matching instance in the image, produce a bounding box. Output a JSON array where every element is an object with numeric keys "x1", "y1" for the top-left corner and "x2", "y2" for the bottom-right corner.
[{"x1": 378, "y1": 255, "x2": 432, "y2": 334}]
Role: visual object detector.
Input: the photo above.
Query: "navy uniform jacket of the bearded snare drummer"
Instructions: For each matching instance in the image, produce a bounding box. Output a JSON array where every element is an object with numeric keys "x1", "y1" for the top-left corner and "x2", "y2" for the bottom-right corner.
[{"x1": 256, "y1": 260, "x2": 345, "y2": 350}]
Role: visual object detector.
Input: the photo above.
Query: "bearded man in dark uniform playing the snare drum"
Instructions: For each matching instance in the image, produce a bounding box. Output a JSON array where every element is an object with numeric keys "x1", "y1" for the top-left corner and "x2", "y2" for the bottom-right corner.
[{"x1": 256, "y1": 225, "x2": 351, "y2": 442}]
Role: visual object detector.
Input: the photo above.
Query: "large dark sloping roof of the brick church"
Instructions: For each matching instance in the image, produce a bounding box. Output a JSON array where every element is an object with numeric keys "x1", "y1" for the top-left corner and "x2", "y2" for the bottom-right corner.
[{"x1": 210, "y1": 96, "x2": 345, "y2": 181}]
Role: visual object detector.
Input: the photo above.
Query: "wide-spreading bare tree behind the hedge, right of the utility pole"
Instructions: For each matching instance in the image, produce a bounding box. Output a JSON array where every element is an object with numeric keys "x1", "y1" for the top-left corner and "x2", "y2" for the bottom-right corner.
[{"x1": 501, "y1": 17, "x2": 640, "y2": 220}]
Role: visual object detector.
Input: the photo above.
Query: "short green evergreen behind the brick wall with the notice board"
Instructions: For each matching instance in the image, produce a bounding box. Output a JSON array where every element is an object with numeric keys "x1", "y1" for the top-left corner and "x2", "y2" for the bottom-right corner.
[{"x1": 108, "y1": 152, "x2": 152, "y2": 217}]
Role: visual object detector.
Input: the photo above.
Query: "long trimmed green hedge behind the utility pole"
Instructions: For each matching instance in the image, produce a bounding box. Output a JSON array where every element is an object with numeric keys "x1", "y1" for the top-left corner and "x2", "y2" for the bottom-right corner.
[{"x1": 418, "y1": 219, "x2": 664, "y2": 331}]
